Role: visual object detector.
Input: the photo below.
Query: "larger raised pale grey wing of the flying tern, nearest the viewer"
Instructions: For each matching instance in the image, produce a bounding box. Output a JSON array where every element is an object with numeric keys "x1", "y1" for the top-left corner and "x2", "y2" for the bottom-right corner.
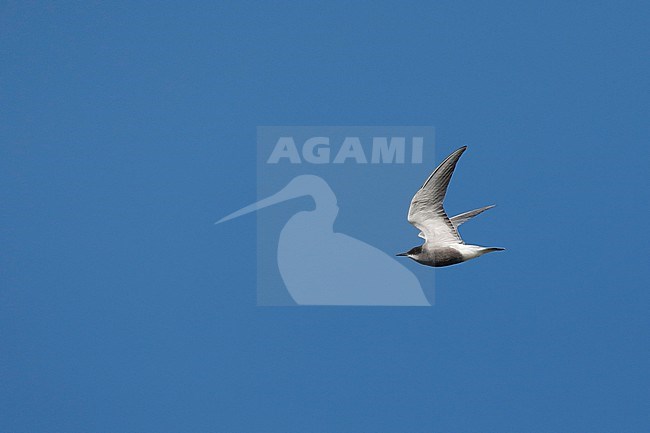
[{"x1": 408, "y1": 146, "x2": 467, "y2": 245}]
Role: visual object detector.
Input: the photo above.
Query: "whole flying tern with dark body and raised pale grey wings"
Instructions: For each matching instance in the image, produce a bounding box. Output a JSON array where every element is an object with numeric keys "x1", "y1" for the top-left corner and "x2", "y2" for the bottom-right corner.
[{"x1": 397, "y1": 146, "x2": 504, "y2": 267}]
